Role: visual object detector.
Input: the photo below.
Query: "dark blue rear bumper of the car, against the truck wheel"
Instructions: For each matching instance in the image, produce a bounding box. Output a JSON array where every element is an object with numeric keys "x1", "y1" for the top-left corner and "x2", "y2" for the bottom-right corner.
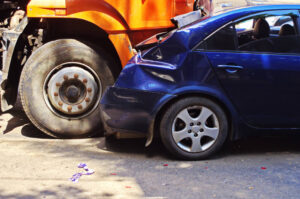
[{"x1": 101, "y1": 87, "x2": 173, "y2": 134}]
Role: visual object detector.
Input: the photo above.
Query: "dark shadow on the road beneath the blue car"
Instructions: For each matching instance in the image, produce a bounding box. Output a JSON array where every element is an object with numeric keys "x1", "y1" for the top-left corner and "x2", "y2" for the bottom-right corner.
[{"x1": 97, "y1": 135, "x2": 300, "y2": 160}]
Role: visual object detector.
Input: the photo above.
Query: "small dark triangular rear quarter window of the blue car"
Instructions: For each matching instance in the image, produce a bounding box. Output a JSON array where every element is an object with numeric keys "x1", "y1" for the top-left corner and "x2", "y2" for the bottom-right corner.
[{"x1": 198, "y1": 25, "x2": 236, "y2": 51}]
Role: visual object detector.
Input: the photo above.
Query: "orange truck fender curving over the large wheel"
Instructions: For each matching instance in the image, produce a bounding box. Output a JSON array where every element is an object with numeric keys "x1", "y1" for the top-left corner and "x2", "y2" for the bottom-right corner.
[{"x1": 27, "y1": 0, "x2": 139, "y2": 66}]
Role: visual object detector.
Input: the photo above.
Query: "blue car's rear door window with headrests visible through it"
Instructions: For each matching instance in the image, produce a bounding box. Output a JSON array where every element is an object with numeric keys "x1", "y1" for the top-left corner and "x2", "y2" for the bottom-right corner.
[{"x1": 235, "y1": 15, "x2": 300, "y2": 53}]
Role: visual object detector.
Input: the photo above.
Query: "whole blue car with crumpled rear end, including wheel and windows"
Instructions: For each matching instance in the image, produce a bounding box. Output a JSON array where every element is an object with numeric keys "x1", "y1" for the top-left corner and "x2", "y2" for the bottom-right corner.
[{"x1": 101, "y1": 5, "x2": 300, "y2": 160}]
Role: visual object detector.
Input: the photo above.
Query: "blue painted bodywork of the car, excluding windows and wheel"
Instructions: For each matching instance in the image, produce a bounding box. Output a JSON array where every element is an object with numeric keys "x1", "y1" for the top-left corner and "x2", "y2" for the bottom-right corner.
[{"x1": 101, "y1": 5, "x2": 300, "y2": 139}]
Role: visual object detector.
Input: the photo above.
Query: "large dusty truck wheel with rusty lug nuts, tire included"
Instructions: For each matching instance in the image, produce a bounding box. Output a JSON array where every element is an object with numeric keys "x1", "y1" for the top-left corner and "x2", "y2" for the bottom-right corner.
[{"x1": 20, "y1": 39, "x2": 117, "y2": 138}]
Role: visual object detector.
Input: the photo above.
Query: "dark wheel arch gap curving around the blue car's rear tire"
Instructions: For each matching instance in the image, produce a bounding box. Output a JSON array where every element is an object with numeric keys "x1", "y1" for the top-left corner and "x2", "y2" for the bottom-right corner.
[{"x1": 146, "y1": 91, "x2": 238, "y2": 146}]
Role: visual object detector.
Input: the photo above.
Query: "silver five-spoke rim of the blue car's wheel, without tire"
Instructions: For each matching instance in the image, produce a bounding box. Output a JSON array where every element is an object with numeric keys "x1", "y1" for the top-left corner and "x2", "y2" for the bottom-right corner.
[{"x1": 172, "y1": 106, "x2": 219, "y2": 153}]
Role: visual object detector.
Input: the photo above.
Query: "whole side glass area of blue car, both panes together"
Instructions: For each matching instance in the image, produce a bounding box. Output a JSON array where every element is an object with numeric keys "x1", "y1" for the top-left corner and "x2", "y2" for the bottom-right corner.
[{"x1": 197, "y1": 11, "x2": 300, "y2": 54}]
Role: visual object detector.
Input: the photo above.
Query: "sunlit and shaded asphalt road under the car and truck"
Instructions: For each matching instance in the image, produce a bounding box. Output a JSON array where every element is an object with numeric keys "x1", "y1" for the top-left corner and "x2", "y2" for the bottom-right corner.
[{"x1": 0, "y1": 110, "x2": 300, "y2": 199}]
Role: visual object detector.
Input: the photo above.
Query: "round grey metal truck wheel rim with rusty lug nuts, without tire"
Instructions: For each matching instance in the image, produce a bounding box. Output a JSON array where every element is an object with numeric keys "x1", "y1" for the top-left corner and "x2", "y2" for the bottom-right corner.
[{"x1": 44, "y1": 62, "x2": 102, "y2": 119}]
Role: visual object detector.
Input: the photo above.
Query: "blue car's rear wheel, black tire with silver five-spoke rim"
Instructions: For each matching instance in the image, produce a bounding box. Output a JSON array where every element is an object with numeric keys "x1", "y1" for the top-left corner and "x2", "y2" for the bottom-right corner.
[{"x1": 160, "y1": 97, "x2": 228, "y2": 160}]
